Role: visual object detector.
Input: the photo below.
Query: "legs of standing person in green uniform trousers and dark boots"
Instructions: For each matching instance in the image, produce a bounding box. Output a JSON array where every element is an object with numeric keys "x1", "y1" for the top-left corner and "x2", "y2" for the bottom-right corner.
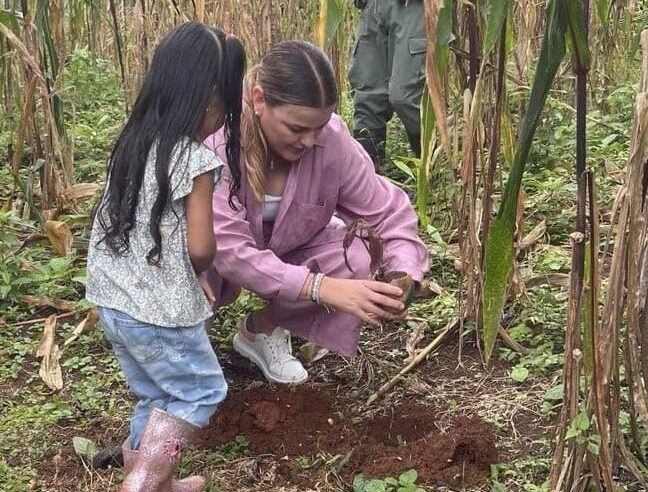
[{"x1": 349, "y1": 0, "x2": 426, "y2": 169}]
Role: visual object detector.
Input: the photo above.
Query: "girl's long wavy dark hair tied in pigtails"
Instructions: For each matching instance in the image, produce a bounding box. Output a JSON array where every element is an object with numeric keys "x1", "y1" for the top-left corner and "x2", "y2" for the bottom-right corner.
[{"x1": 96, "y1": 22, "x2": 245, "y2": 265}]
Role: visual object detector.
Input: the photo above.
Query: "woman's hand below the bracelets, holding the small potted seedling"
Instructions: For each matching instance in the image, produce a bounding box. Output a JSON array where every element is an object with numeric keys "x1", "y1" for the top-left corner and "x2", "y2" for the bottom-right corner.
[{"x1": 319, "y1": 277, "x2": 405, "y2": 325}]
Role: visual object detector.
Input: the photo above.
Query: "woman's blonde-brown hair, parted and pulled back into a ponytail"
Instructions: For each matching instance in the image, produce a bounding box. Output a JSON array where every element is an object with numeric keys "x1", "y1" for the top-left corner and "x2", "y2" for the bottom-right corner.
[{"x1": 241, "y1": 41, "x2": 337, "y2": 202}]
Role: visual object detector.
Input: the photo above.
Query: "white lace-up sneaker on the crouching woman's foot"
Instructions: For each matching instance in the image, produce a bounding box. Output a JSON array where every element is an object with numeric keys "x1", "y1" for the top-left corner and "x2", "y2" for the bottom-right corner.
[{"x1": 233, "y1": 326, "x2": 308, "y2": 384}]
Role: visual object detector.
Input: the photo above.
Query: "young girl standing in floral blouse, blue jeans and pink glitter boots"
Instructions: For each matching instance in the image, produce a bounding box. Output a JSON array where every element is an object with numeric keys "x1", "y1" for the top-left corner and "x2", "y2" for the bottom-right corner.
[{"x1": 86, "y1": 22, "x2": 245, "y2": 492}]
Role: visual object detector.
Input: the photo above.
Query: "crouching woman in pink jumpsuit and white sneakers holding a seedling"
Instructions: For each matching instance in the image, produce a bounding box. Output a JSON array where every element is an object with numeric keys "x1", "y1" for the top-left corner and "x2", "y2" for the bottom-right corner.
[{"x1": 205, "y1": 41, "x2": 428, "y2": 383}]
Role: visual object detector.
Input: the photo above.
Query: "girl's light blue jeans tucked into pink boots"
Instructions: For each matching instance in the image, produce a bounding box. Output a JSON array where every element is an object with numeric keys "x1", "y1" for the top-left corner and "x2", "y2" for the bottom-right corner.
[{"x1": 99, "y1": 307, "x2": 227, "y2": 449}]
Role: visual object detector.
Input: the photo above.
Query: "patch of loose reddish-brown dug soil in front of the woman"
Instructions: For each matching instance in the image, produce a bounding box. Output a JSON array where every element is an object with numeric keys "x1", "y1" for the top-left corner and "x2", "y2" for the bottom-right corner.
[{"x1": 201, "y1": 386, "x2": 498, "y2": 488}]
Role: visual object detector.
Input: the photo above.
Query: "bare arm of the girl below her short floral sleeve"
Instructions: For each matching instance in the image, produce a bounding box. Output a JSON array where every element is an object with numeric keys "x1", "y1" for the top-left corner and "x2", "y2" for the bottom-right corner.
[{"x1": 185, "y1": 171, "x2": 216, "y2": 273}]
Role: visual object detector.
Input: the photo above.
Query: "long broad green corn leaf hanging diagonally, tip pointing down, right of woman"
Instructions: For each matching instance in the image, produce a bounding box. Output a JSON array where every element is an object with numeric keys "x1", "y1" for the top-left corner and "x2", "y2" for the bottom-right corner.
[{"x1": 482, "y1": 0, "x2": 567, "y2": 361}]
